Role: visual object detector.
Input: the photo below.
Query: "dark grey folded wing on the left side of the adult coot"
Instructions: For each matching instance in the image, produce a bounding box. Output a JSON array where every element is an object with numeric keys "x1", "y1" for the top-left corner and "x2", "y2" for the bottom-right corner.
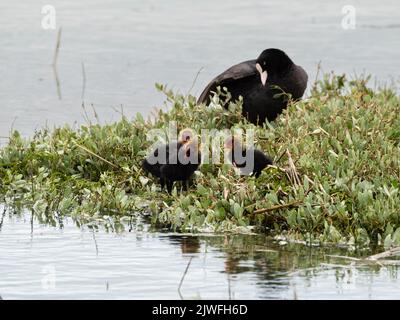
[{"x1": 197, "y1": 60, "x2": 257, "y2": 104}]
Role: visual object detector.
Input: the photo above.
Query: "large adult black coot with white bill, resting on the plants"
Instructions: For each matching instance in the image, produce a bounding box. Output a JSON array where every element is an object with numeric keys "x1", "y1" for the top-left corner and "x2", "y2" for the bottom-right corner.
[{"x1": 197, "y1": 49, "x2": 308, "y2": 125}]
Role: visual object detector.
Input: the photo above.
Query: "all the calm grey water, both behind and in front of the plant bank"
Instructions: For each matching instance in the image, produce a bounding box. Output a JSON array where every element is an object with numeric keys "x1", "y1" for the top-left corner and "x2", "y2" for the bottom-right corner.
[{"x1": 0, "y1": 0, "x2": 400, "y2": 299}]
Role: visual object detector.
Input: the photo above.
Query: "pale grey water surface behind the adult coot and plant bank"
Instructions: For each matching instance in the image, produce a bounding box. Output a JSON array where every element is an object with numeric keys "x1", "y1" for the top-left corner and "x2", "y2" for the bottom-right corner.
[{"x1": 0, "y1": 0, "x2": 400, "y2": 140}]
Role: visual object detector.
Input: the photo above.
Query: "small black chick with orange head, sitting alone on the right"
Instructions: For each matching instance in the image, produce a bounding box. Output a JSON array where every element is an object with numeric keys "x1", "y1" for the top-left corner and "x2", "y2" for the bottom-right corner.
[{"x1": 225, "y1": 136, "x2": 273, "y2": 178}]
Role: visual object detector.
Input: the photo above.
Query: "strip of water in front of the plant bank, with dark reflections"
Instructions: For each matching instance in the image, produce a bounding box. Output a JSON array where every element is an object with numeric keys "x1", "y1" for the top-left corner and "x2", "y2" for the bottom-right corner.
[{"x1": 0, "y1": 208, "x2": 400, "y2": 299}]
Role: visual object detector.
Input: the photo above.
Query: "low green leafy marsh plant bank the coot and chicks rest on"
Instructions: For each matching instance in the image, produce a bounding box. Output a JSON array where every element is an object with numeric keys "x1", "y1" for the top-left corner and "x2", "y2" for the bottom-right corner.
[{"x1": 0, "y1": 75, "x2": 400, "y2": 247}]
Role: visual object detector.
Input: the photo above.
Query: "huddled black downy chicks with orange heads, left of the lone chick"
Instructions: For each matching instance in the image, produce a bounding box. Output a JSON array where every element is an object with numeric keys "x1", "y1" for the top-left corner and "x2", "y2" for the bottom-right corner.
[{"x1": 142, "y1": 131, "x2": 201, "y2": 192}]
